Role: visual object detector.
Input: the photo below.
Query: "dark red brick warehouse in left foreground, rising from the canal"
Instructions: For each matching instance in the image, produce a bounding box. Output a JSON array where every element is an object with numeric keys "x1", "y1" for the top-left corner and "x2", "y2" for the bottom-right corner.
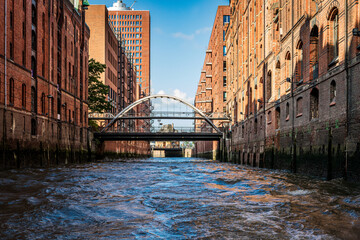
[{"x1": 0, "y1": 0, "x2": 90, "y2": 168}]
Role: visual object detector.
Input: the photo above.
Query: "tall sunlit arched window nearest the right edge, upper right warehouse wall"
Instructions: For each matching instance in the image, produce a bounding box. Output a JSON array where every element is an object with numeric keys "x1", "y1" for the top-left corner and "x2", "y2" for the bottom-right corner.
[{"x1": 328, "y1": 7, "x2": 339, "y2": 67}]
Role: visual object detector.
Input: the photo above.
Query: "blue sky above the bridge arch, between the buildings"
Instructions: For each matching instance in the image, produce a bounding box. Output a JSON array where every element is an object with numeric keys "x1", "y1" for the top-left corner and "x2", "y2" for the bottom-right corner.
[{"x1": 89, "y1": 0, "x2": 229, "y2": 103}]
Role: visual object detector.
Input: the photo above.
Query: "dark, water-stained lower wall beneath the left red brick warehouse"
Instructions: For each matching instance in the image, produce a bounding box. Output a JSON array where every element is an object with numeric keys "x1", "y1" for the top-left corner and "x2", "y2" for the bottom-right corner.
[{"x1": 0, "y1": 109, "x2": 96, "y2": 170}]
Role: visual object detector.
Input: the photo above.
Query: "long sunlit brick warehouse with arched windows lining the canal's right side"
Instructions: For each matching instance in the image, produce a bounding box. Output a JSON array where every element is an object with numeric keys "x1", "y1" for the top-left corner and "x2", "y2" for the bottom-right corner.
[{"x1": 217, "y1": 0, "x2": 360, "y2": 181}]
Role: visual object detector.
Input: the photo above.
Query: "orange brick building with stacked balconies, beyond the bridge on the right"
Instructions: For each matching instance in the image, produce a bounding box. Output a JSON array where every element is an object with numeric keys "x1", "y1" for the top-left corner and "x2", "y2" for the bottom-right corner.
[{"x1": 195, "y1": 6, "x2": 230, "y2": 156}]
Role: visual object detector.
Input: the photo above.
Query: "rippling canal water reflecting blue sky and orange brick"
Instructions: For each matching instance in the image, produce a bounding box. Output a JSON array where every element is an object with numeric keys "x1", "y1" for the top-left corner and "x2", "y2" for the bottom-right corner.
[{"x1": 0, "y1": 158, "x2": 360, "y2": 239}]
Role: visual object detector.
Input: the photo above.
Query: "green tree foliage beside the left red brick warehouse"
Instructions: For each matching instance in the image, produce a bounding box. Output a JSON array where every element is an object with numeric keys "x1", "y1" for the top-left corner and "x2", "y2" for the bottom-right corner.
[{"x1": 88, "y1": 58, "x2": 111, "y2": 113}]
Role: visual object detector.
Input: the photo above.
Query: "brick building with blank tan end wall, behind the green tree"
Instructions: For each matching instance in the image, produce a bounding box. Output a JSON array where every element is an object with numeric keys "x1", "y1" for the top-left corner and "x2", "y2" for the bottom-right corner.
[{"x1": 86, "y1": 5, "x2": 150, "y2": 155}]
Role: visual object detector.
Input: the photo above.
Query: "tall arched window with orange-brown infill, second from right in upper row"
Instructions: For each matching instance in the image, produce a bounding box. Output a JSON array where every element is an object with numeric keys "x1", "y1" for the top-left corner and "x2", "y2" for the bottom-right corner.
[{"x1": 310, "y1": 25, "x2": 319, "y2": 79}]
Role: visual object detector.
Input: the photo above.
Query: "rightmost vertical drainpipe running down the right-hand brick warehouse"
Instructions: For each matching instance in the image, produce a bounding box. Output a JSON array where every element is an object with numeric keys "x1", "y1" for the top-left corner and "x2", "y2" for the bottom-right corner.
[{"x1": 343, "y1": 0, "x2": 351, "y2": 180}]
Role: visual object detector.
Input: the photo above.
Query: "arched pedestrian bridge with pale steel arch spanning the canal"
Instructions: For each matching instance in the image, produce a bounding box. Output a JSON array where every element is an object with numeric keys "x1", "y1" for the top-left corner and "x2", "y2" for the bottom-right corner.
[{"x1": 89, "y1": 94, "x2": 230, "y2": 141}]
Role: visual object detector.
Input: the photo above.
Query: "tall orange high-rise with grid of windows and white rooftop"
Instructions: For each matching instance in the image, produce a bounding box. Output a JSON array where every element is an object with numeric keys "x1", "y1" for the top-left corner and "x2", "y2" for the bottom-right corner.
[{"x1": 108, "y1": 0, "x2": 150, "y2": 96}]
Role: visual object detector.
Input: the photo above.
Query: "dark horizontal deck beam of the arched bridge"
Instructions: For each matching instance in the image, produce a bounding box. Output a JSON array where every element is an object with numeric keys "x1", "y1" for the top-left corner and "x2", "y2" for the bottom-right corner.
[{"x1": 94, "y1": 132, "x2": 222, "y2": 141}]
